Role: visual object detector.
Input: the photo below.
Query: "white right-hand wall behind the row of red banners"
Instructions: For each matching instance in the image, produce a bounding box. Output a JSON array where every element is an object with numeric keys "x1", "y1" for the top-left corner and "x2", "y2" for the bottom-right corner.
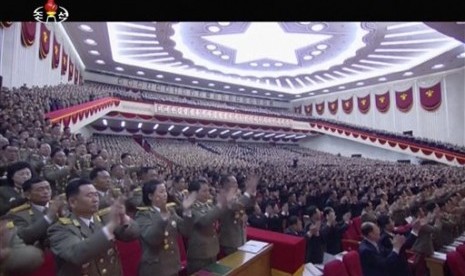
[{"x1": 292, "y1": 68, "x2": 465, "y2": 145}]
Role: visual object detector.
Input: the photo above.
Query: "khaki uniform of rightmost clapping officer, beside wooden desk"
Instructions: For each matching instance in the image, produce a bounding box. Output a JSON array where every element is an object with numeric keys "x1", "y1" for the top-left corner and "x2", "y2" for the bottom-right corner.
[{"x1": 220, "y1": 195, "x2": 253, "y2": 255}]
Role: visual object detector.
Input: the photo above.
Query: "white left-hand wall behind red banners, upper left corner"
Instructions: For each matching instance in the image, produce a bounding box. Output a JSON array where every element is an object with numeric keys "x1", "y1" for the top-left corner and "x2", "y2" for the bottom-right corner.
[{"x1": 0, "y1": 22, "x2": 84, "y2": 88}]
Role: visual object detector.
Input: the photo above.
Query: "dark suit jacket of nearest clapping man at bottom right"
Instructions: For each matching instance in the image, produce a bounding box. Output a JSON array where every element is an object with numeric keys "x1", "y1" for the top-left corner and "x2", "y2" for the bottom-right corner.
[{"x1": 358, "y1": 239, "x2": 401, "y2": 276}]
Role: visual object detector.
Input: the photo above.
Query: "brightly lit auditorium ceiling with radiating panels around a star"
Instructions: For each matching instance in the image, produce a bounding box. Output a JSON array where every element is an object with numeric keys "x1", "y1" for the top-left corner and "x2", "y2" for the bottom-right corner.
[{"x1": 64, "y1": 22, "x2": 465, "y2": 101}]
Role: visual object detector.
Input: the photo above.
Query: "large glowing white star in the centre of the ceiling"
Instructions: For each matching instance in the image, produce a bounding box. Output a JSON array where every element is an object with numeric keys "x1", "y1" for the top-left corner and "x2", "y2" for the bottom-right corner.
[{"x1": 203, "y1": 22, "x2": 332, "y2": 65}]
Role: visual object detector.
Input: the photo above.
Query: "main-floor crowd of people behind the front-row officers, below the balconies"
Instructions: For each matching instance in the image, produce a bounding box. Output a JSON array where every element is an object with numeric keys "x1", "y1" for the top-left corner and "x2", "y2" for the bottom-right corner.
[{"x1": 0, "y1": 84, "x2": 465, "y2": 276}]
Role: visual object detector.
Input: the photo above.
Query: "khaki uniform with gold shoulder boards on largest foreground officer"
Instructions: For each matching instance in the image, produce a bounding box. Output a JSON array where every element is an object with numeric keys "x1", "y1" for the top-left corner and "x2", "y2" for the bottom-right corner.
[{"x1": 48, "y1": 213, "x2": 139, "y2": 276}]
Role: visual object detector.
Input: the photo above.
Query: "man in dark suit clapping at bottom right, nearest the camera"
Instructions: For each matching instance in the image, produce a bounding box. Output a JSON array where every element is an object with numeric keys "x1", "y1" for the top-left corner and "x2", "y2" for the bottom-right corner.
[{"x1": 358, "y1": 222, "x2": 405, "y2": 276}]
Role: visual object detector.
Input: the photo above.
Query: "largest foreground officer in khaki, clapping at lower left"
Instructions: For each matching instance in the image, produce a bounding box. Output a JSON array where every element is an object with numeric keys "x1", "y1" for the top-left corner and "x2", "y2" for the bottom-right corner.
[{"x1": 48, "y1": 178, "x2": 139, "y2": 276}]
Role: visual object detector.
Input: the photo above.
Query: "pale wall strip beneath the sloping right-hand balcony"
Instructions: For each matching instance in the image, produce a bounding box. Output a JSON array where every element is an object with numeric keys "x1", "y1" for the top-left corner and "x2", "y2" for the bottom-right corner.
[{"x1": 300, "y1": 135, "x2": 420, "y2": 164}]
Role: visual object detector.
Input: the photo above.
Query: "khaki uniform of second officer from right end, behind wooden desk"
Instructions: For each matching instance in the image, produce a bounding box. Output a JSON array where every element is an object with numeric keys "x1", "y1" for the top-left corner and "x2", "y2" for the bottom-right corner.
[{"x1": 187, "y1": 201, "x2": 225, "y2": 273}]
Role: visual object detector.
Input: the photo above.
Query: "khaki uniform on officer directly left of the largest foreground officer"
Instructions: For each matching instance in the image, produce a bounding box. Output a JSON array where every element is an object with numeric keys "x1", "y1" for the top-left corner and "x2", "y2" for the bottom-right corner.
[{"x1": 8, "y1": 203, "x2": 50, "y2": 250}]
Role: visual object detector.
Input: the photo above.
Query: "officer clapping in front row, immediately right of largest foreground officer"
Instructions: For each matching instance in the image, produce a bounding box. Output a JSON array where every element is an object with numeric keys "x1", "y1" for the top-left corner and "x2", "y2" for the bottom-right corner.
[{"x1": 136, "y1": 180, "x2": 197, "y2": 276}]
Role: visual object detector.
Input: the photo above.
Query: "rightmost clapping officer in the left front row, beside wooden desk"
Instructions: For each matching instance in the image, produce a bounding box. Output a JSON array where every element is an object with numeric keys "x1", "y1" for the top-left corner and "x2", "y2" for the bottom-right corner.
[{"x1": 219, "y1": 175, "x2": 259, "y2": 255}]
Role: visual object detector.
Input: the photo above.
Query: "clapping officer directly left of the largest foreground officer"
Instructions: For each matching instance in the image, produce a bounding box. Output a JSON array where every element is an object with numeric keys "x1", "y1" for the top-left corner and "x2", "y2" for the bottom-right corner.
[{"x1": 8, "y1": 178, "x2": 65, "y2": 249}]
